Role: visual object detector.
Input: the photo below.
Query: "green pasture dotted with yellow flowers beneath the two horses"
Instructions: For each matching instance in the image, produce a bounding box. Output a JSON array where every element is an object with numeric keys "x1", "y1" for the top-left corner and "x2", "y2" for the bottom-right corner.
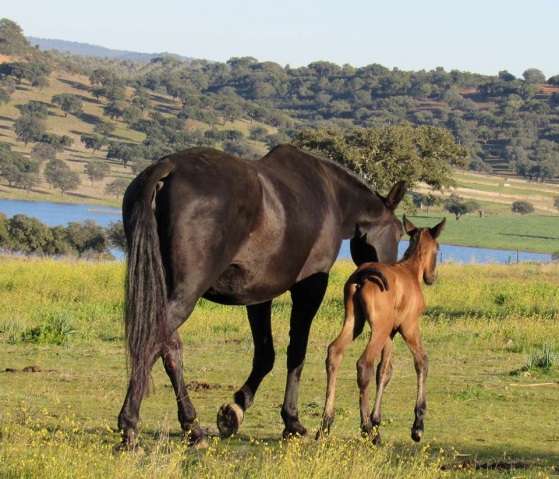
[{"x1": 0, "y1": 257, "x2": 559, "y2": 479}]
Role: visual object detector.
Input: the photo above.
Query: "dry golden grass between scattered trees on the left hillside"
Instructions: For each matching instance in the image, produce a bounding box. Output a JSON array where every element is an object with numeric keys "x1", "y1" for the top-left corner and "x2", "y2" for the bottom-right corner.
[{"x1": 0, "y1": 57, "x2": 274, "y2": 206}]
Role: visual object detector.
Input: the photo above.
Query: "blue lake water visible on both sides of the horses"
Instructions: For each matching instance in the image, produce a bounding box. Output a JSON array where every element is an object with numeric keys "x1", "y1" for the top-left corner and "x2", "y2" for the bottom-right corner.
[{"x1": 0, "y1": 199, "x2": 551, "y2": 263}]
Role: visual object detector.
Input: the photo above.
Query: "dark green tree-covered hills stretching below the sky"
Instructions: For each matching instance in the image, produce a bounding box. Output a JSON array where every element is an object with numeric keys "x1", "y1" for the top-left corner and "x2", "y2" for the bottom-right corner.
[{"x1": 0, "y1": 19, "x2": 559, "y2": 184}]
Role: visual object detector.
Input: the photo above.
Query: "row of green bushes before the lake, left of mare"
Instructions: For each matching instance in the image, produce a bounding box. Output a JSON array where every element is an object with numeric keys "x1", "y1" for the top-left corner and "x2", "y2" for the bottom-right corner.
[{"x1": 0, "y1": 213, "x2": 126, "y2": 260}]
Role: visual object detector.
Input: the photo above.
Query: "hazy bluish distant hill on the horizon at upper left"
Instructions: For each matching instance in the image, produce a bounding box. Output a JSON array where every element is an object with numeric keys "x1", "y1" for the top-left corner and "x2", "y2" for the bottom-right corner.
[{"x1": 27, "y1": 37, "x2": 194, "y2": 62}]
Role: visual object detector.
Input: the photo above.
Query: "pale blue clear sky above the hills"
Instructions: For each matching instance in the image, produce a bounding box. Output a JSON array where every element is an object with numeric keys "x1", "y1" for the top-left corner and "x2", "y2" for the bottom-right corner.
[{"x1": 4, "y1": 0, "x2": 559, "y2": 77}]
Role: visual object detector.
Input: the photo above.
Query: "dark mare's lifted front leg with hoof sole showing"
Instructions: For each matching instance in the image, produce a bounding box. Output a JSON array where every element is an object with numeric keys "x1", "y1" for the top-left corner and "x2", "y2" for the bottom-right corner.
[{"x1": 217, "y1": 301, "x2": 275, "y2": 437}]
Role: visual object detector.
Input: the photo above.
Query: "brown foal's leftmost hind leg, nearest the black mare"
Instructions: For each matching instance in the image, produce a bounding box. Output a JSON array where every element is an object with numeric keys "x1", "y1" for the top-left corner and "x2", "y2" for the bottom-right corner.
[{"x1": 316, "y1": 283, "x2": 365, "y2": 439}]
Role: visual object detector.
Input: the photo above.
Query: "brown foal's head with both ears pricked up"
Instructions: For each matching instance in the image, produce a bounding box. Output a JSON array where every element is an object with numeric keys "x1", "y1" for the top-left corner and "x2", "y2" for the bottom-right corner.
[{"x1": 403, "y1": 215, "x2": 446, "y2": 285}]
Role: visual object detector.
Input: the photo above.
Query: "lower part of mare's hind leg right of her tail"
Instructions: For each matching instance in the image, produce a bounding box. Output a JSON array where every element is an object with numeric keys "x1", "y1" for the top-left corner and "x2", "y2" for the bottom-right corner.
[{"x1": 161, "y1": 331, "x2": 207, "y2": 448}]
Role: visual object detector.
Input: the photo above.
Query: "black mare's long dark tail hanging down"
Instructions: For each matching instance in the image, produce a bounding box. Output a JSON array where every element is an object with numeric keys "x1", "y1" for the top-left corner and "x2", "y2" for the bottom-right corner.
[{"x1": 122, "y1": 162, "x2": 174, "y2": 397}]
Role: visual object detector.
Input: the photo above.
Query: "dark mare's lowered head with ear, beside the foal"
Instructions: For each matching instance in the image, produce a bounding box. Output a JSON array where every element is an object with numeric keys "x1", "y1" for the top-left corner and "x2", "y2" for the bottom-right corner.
[{"x1": 349, "y1": 181, "x2": 406, "y2": 266}]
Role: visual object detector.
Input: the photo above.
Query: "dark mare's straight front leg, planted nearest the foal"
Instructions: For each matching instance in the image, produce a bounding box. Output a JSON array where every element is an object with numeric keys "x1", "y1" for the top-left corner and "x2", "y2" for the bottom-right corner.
[{"x1": 281, "y1": 273, "x2": 328, "y2": 438}]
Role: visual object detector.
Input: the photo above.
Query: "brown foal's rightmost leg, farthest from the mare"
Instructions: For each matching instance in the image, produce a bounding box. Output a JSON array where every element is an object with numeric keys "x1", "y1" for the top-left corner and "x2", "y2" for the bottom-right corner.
[{"x1": 400, "y1": 321, "x2": 429, "y2": 442}]
